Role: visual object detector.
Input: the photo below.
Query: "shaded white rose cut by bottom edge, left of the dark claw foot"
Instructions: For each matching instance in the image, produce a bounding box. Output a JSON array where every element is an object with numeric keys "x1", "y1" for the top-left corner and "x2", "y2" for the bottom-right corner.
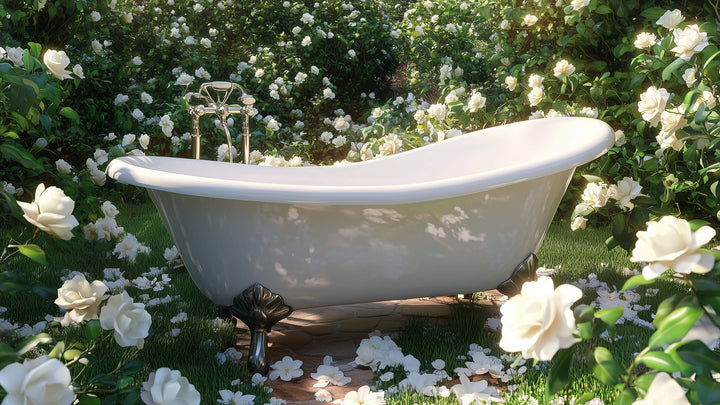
[{"x1": 140, "y1": 367, "x2": 200, "y2": 405}]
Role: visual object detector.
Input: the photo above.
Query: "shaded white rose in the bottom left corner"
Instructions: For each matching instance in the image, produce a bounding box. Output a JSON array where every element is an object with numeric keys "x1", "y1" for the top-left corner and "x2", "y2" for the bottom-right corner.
[{"x1": 0, "y1": 356, "x2": 75, "y2": 405}]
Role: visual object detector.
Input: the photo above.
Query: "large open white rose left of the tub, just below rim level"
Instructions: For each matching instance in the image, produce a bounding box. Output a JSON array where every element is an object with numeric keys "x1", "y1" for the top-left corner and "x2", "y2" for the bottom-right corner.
[{"x1": 17, "y1": 183, "x2": 79, "y2": 240}]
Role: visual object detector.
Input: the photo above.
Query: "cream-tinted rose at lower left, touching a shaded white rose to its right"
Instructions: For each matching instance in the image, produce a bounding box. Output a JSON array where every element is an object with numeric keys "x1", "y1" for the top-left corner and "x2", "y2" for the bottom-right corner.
[{"x1": 55, "y1": 274, "x2": 108, "y2": 326}]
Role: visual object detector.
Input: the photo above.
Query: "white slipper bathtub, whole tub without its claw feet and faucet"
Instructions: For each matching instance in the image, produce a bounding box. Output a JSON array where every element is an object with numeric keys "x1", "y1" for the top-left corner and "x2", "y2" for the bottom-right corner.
[{"x1": 108, "y1": 118, "x2": 614, "y2": 309}]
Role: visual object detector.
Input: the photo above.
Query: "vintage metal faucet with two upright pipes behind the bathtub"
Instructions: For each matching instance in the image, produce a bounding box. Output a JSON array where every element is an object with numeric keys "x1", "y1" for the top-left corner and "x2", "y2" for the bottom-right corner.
[{"x1": 185, "y1": 82, "x2": 255, "y2": 164}]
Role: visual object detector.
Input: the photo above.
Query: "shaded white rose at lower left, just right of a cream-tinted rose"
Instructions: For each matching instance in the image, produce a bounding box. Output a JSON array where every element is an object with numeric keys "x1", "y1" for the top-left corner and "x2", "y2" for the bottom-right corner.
[{"x1": 100, "y1": 291, "x2": 152, "y2": 349}]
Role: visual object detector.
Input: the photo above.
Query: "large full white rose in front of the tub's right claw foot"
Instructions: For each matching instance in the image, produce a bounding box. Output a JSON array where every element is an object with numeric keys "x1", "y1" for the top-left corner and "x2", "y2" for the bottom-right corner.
[{"x1": 500, "y1": 276, "x2": 582, "y2": 360}]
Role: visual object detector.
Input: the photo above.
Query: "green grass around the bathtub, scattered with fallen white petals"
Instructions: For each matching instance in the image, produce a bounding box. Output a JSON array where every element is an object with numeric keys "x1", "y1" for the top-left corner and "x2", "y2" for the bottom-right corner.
[{"x1": 0, "y1": 203, "x2": 692, "y2": 404}]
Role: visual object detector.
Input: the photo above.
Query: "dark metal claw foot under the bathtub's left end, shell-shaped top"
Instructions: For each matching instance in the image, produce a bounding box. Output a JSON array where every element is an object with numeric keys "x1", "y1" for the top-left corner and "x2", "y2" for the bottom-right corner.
[{"x1": 230, "y1": 283, "x2": 292, "y2": 375}]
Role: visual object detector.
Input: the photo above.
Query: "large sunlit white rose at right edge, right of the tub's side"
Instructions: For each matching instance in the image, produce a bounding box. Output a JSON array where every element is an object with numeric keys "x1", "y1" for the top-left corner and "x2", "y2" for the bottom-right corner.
[{"x1": 630, "y1": 216, "x2": 715, "y2": 280}]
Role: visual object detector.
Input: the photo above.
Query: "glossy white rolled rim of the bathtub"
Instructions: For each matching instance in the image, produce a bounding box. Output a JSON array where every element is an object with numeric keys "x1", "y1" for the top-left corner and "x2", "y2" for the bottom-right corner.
[{"x1": 106, "y1": 117, "x2": 614, "y2": 205}]
